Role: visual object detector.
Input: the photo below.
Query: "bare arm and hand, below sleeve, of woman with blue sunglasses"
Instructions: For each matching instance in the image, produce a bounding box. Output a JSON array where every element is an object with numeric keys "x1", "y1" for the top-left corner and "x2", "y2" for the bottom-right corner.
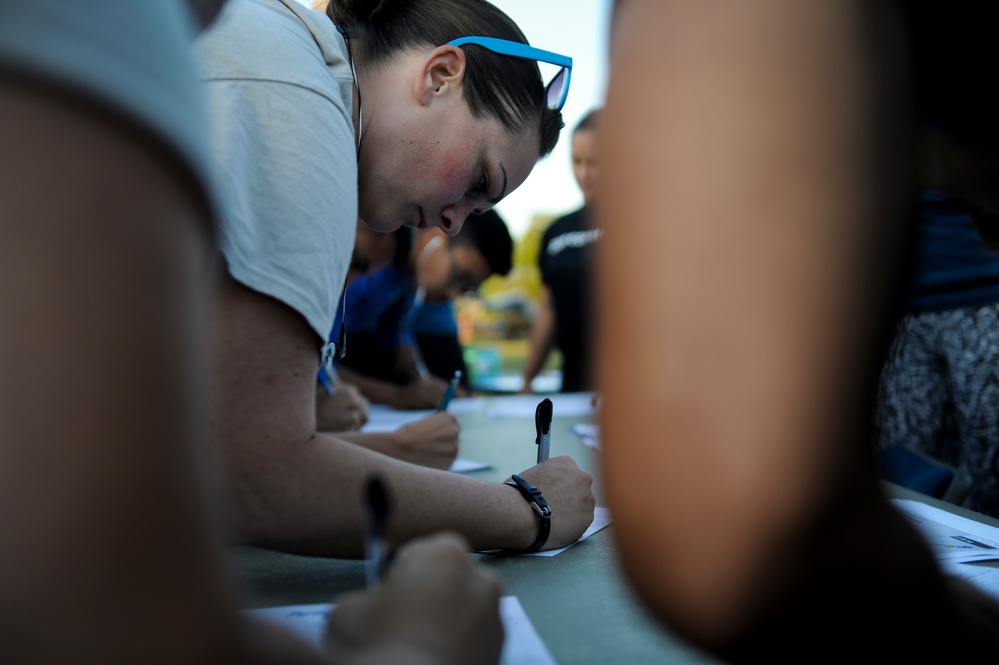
[{"x1": 205, "y1": 279, "x2": 594, "y2": 557}]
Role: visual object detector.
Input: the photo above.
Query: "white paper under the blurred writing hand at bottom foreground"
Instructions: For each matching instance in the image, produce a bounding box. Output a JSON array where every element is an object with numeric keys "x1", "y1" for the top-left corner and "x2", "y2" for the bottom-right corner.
[{"x1": 244, "y1": 596, "x2": 556, "y2": 665}]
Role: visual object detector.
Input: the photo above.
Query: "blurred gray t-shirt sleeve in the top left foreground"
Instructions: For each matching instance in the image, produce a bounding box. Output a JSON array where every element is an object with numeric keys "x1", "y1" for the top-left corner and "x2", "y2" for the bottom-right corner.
[{"x1": 0, "y1": 0, "x2": 215, "y2": 220}]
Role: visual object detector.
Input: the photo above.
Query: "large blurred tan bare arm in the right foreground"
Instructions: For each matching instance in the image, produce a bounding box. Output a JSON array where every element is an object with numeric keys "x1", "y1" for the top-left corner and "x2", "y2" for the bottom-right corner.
[{"x1": 598, "y1": 0, "x2": 904, "y2": 648}]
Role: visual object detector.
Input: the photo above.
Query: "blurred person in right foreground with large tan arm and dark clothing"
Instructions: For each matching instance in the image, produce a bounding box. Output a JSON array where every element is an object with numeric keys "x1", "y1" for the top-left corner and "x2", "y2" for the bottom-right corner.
[{"x1": 597, "y1": 0, "x2": 999, "y2": 663}]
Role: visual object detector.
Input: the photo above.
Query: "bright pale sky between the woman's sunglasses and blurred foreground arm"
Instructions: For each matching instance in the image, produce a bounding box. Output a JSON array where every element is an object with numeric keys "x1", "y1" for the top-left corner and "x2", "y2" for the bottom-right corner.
[{"x1": 299, "y1": 0, "x2": 611, "y2": 238}]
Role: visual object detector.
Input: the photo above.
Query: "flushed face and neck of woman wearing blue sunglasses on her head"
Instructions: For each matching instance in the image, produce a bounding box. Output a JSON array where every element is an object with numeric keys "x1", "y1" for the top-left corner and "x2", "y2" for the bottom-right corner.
[{"x1": 358, "y1": 55, "x2": 539, "y2": 235}]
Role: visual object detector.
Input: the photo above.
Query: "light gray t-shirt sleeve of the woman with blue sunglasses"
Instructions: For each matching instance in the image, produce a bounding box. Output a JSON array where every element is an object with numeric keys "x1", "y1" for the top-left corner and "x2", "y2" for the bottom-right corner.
[{"x1": 195, "y1": 0, "x2": 357, "y2": 342}]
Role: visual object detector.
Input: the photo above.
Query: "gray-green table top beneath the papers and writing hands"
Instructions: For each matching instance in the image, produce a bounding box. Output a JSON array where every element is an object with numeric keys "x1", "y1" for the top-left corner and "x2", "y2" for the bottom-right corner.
[{"x1": 231, "y1": 397, "x2": 997, "y2": 665}]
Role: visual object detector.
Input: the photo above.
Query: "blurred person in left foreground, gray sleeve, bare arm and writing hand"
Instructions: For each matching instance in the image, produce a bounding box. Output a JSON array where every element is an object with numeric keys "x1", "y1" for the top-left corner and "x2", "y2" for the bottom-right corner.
[{"x1": 0, "y1": 0, "x2": 503, "y2": 665}]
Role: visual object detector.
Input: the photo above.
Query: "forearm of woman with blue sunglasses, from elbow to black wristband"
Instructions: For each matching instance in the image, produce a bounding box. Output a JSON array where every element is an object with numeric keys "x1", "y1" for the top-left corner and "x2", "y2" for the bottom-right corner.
[{"x1": 229, "y1": 426, "x2": 536, "y2": 558}]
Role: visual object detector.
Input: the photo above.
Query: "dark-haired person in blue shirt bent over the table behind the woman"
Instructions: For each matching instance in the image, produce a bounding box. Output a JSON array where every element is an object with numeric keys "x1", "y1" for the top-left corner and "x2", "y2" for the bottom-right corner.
[{"x1": 330, "y1": 210, "x2": 513, "y2": 409}]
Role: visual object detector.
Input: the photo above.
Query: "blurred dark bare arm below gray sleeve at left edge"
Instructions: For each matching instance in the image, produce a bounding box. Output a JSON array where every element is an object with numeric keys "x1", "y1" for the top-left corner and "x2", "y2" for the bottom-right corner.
[{"x1": 0, "y1": 87, "x2": 256, "y2": 665}]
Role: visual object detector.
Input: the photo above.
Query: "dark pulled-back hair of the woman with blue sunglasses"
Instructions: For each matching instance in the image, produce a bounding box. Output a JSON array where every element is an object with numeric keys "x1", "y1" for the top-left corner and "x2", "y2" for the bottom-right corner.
[{"x1": 326, "y1": 0, "x2": 564, "y2": 158}]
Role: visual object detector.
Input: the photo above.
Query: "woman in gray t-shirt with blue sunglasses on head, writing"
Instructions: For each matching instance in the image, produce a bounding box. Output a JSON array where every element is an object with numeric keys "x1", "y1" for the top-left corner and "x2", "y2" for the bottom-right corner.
[{"x1": 197, "y1": 0, "x2": 594, "y2": 556}]
